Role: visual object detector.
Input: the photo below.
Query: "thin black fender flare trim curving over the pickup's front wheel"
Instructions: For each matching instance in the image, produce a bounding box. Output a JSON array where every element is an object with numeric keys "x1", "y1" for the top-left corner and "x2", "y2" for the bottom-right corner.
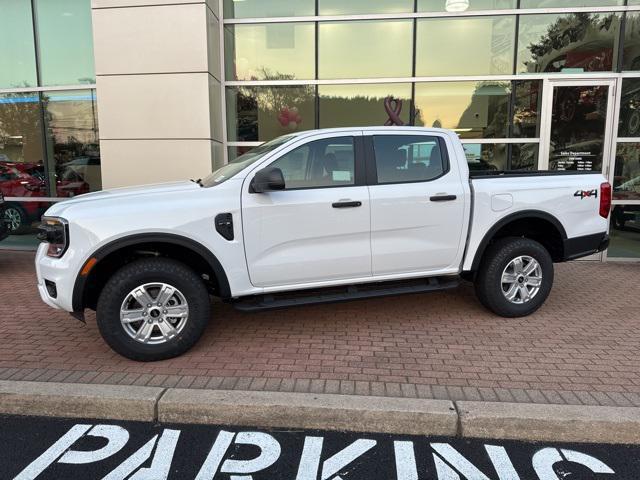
[{"x1": 72, "y1": 233, "x2": 231, "y2": 312}]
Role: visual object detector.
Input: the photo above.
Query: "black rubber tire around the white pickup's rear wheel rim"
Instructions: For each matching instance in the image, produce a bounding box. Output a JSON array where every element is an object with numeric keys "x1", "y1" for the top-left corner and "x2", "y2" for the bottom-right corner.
[{"x1": 475, "y1": 237, "x2": 554, "y2": 318}]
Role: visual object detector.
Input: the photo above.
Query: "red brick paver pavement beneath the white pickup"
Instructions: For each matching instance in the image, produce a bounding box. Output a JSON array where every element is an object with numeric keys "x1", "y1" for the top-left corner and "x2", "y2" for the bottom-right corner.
[{"x1": 0, "y1": 251, "x2": 640, "y2": 406}]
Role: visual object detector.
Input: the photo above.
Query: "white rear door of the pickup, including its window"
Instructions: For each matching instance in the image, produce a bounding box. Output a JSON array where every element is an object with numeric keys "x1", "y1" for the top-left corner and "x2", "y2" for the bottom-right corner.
[{"x1": 365, "y1": 130, "x2": 468, "y2": 275}]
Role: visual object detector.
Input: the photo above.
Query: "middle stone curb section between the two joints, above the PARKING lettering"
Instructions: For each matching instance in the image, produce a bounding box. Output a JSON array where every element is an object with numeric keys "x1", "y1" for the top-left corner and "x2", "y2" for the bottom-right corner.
[{"x1": 158, "y1": 389, "x2": 458, "y2": 436}]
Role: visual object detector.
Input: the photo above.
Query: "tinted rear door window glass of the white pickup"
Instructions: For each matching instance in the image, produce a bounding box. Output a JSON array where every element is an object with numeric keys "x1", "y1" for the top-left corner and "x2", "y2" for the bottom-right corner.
[{"x1": 373, "y1": 135, "x2": 446, "y2": 183}]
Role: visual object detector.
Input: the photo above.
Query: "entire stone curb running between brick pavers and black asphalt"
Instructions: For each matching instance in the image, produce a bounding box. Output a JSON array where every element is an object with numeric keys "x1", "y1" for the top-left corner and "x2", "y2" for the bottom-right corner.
[{"x1": 0, "y1": 381, "x2": 640, "y2": 445}]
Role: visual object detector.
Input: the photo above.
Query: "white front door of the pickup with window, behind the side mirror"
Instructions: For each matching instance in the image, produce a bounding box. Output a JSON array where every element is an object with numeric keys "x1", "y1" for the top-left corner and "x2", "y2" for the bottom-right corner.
[{"x1": 242, "y1": 134, "x2": 371, "y2": 287}]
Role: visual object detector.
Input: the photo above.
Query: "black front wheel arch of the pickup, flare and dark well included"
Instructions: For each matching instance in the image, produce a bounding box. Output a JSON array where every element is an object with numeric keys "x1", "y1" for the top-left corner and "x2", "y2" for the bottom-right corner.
[{"x1": 73, "y1": 233, "x2": 231, "y2": 312}]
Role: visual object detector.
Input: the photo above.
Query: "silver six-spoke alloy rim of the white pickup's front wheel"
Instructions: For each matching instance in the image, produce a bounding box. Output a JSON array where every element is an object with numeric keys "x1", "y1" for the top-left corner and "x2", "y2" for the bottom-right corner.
[{"x1": 120, "y1": 283, "x2": 189, "y2": 345}]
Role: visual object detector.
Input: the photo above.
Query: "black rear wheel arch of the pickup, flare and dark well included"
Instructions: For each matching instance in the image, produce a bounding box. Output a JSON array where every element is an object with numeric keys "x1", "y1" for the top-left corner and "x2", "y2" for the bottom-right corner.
[{"x1": 471, "y1": 210, "x2": 567, "y2": 274}]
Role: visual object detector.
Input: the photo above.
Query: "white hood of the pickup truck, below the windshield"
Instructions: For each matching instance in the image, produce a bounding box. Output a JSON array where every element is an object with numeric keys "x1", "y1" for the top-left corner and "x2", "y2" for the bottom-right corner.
[{"x1": 46, "y1": 180, "x2": 202, "y2": 216}]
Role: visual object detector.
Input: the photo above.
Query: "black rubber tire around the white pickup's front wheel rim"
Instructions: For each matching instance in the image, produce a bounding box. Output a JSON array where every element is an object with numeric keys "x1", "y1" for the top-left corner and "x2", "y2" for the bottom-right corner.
[{"x1": 96, "y1": 258, "x2": 211, "y2": 362}]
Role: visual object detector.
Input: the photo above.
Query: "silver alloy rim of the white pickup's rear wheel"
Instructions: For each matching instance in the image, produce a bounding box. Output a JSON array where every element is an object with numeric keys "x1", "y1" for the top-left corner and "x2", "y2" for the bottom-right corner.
[{"x1": 501, "y1": 255, "x2": 542, "y2": 305}]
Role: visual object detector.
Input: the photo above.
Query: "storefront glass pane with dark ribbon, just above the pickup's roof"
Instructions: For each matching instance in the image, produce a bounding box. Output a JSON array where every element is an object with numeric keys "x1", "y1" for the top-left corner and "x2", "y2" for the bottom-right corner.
[{"x1": 318, "y1": 83, "x2": 411, "y2": 128}]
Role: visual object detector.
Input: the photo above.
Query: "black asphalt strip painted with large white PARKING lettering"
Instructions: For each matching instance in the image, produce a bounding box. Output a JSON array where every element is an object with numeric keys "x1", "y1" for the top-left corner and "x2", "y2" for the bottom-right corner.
[{"x1": 0, "y1": 417, "x2": 640, "y2": 480}]
